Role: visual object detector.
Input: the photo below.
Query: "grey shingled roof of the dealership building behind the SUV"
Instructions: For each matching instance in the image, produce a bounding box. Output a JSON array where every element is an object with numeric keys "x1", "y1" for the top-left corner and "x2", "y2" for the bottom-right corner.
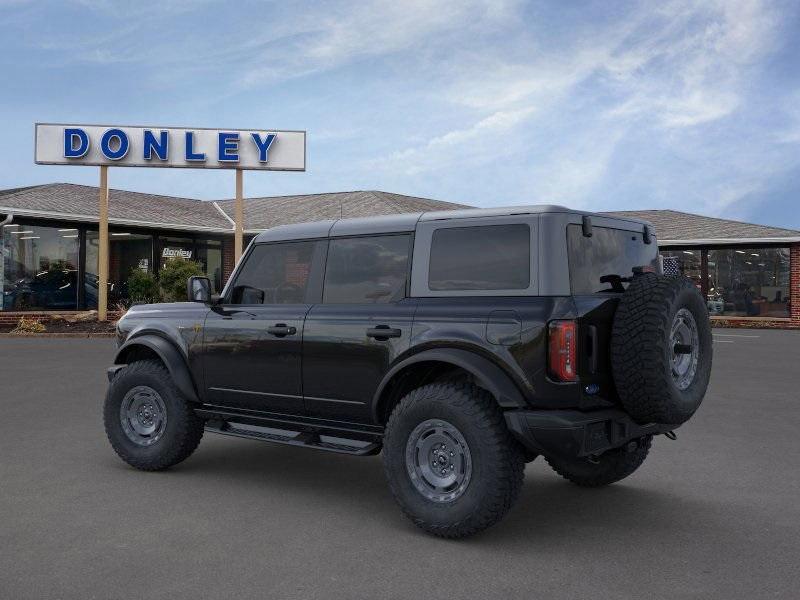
[{"x1": 0, "y1": 183, "x2": 800, "y2": 245}]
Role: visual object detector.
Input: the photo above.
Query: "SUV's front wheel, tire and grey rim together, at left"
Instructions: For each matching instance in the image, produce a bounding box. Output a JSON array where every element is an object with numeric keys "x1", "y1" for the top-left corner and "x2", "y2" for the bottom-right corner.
[{"x1": 103, "y1": 360, "x2": 204, "y2": 471}]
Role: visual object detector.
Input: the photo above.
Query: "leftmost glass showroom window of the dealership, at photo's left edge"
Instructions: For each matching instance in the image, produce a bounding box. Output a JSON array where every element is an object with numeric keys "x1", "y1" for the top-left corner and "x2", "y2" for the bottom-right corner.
[{"x1": 0, "y1": 224, "x2": 80, "y2": 310}]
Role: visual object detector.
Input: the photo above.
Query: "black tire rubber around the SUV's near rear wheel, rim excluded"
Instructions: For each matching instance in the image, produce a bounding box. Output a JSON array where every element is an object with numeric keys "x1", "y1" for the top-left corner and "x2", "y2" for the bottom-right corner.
[{"x1": 383, "y1": 380, "x2": 525, "y2": 538}]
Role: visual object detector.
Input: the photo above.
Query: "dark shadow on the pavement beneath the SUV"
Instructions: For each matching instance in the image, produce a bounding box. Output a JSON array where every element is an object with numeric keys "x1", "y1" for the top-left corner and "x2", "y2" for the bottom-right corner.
[{"x1": 131, "y1": 436, "x2": 728, "y2": 546}]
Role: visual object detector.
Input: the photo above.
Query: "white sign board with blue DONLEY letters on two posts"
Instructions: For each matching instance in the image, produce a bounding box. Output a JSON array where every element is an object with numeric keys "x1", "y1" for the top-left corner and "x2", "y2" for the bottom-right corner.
[{"x1": 35, "y1": 123, "x2": 306, "y2": 171}]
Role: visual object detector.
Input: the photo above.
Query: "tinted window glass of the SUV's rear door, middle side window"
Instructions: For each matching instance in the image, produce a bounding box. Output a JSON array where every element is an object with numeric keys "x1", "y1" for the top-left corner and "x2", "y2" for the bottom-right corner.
[{"x1": 322, "y1": 235, "x2": 411, "y2": 304}]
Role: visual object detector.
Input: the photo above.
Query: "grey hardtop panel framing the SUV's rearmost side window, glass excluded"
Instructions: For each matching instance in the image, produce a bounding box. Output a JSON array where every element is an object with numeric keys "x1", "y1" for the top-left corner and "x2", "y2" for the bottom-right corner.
[{"x1": 410, "y1": 214, "x2": 540, "y2": 298}]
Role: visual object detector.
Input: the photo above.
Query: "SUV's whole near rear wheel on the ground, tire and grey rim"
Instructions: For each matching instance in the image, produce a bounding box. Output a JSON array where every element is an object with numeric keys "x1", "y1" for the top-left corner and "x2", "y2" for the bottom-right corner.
[{"x1": 383, "y1": 381, "x2": 525, "y2": 538}]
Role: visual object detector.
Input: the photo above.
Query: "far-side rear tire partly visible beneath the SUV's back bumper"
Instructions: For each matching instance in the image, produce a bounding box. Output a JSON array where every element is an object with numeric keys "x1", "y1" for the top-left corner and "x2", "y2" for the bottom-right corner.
[{"x1": 545, "y1": 435, "x2": 653, "y2": 487}]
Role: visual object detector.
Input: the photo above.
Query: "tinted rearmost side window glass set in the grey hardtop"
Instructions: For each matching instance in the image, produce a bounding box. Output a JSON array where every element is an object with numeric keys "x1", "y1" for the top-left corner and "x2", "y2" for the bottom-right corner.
[{"x1": 428, "y1": 224, "x2": 531, "y2": 291}]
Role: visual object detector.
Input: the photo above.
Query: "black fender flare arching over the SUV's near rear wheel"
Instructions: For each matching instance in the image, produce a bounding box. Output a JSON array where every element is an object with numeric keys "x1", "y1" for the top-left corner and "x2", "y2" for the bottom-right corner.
[{"x1": 372, "y1": 348, "x2": 528, "y2": 423}]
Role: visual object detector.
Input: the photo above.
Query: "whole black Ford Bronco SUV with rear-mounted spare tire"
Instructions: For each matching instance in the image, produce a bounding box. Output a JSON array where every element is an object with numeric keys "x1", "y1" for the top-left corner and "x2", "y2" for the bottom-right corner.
[{"x1": 104, "y1": 206, "x2": 712, "y2": 538}]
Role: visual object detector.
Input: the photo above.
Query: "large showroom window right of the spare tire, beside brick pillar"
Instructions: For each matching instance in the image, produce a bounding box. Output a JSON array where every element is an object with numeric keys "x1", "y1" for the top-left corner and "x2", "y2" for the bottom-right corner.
[{"x1": 708, "y1": 248, "x2": 790, "y2": 319}]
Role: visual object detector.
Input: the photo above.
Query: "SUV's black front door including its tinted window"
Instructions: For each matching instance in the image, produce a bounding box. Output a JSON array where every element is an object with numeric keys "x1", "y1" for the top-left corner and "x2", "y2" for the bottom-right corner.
[{"x1": 203, "y1": 241, "x2": 322, "y2": 414}]
